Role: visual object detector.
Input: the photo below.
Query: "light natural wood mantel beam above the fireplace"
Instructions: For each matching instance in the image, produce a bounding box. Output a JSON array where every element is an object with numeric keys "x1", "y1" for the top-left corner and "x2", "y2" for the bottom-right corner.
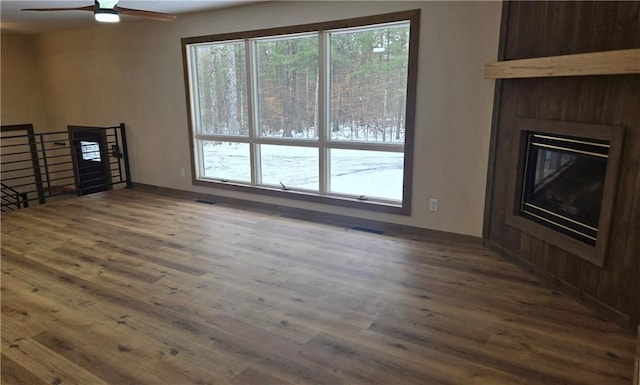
[{"x1": 484, "y1": 48, "x2": 640, "y2": 79}]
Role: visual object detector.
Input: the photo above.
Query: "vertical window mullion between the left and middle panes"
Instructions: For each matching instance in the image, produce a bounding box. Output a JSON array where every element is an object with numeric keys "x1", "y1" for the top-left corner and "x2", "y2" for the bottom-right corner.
[{"x1": 245, "y1": 39, "x2": 262, "y2": 185}]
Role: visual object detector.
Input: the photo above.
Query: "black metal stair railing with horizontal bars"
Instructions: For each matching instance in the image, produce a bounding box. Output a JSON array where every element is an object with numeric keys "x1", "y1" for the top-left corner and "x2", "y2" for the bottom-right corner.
[{"x1": 0, "y1": 123, "x2": 133, "y2": 211}]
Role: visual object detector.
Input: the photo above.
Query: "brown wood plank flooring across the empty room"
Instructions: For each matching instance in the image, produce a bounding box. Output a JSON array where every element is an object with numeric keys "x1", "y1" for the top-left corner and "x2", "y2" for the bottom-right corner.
[{"x1": 1, "y1": 190, "x2": 635, "y2": 385}]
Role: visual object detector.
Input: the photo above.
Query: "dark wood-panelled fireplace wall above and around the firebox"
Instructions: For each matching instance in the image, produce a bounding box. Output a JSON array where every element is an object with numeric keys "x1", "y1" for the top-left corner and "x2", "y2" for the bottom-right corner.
[{"x1": 483, "y1": 1, "x2": 640, "y2": 332}]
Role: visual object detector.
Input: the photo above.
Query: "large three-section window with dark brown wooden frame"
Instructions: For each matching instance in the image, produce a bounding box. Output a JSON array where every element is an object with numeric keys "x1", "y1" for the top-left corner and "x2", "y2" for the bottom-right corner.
[{"x1": 182, "y1": 11, "x2": 419, "y2": 214}]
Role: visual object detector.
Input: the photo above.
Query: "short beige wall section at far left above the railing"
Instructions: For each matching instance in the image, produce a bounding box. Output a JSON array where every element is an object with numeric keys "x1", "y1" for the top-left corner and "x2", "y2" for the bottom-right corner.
[{"x1": 0, "y1": 32, "x2": 47, "y2": 131}]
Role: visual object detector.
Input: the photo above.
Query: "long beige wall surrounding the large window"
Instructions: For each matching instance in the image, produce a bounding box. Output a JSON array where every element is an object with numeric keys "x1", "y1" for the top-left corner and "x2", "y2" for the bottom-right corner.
[{"x1": 26, "y1": 1, "x2": 501, "y2": 236}]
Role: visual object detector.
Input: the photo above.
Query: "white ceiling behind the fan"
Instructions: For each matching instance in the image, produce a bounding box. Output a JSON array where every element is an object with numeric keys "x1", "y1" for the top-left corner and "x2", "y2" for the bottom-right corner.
[{"x1": 0, "y1": 0, "x2": 260, "y2": 34}]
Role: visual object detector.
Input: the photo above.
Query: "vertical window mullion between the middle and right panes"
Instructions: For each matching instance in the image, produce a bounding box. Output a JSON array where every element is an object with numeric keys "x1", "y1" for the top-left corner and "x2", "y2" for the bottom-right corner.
[{"x1": 318, "y1": 31, "x2": 331, "y2": 194}]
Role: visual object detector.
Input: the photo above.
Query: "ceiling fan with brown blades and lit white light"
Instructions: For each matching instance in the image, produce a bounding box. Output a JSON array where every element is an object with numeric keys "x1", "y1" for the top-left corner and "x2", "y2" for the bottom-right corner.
[{"x1": 22, "y1": 0, "x2": 176, "y2": 23}]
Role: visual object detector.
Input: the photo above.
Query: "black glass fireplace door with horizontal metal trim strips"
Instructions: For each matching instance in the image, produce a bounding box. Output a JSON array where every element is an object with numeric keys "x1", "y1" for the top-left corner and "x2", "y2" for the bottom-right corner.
[{"x1": 520, "y1": 132, "x2": 609, "y2": 245}]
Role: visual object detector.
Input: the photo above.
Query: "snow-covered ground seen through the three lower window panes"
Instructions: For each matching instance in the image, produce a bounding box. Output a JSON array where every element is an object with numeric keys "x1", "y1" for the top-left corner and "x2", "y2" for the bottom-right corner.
[{"x1": 203, "y1": 141, "x2": 404, "y2": 201}]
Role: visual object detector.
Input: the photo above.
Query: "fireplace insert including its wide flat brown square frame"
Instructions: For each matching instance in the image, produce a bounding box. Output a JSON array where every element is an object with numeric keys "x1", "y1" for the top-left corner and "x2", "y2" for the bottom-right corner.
[{"x1": 506, "y1": 119, "x2": 622, "y2": 266}]
